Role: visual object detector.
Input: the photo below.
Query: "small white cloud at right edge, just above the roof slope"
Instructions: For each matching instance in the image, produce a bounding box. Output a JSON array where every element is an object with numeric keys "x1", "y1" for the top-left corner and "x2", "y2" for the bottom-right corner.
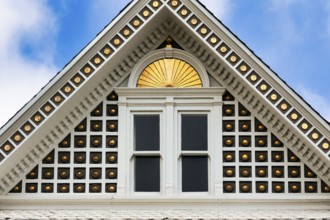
[{"x1": 298, "y1": 86, "x2": 330, "y2": 122}]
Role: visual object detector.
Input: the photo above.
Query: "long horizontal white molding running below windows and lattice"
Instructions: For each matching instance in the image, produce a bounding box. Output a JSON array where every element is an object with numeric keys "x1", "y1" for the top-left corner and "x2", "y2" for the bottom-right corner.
[{"x1": 0, "y1": 195, "x2": 330, "y2": 210}]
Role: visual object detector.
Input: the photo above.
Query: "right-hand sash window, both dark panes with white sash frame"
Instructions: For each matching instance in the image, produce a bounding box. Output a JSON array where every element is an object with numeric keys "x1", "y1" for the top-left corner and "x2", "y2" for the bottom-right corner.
[{"x1": 177, "y1": 111, "x2": 211, "y2": 193}]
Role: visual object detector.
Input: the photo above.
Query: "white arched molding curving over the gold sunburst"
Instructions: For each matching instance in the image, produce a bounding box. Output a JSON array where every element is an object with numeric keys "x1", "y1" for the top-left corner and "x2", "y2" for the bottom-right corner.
[{"x1": 128, "y1": 48, "x2": 210, "y2": 88}]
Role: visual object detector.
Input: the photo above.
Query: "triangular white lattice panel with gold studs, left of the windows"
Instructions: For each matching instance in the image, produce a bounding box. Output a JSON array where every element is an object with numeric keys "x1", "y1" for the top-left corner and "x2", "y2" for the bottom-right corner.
[{"x1": 10, "y1": 93, "x2": 118, "y2": 193}]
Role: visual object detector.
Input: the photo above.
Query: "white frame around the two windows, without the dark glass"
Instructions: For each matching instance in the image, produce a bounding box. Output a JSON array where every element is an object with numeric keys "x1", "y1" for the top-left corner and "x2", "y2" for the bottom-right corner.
[{"x1": 115, "y1": 88, "x2": 225, "y2": 199}]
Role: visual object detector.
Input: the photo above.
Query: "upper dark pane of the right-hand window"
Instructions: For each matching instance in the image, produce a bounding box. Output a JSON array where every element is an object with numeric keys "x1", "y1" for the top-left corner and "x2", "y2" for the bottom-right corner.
[{"x1": 181, "y1": 115, "x2": 207, "y2": 150}]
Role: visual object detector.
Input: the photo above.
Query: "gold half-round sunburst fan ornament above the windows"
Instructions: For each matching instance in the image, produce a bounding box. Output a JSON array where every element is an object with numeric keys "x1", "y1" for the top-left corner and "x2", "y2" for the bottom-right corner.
[{"x1": 137, "y1": 59, "x2": 203, "y2": 88}]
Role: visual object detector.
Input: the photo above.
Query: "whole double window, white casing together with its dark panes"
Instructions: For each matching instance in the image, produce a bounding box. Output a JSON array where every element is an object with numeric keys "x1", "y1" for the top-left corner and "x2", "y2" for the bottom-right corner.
[{"x1": 116, "y1": 88, "x2": 223, "y2": 197}]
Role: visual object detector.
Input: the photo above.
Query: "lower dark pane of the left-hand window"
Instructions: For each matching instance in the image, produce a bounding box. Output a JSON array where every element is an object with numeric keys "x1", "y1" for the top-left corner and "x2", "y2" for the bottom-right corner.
[{"x1": 135, "y1": 156, "x2": 160, "y2": 192}]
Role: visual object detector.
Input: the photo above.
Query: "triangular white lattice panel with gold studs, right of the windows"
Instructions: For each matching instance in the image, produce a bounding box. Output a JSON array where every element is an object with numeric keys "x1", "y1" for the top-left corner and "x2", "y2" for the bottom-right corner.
[{"x1": 223, "y1": 93, "x2": 330, "y2": 194}]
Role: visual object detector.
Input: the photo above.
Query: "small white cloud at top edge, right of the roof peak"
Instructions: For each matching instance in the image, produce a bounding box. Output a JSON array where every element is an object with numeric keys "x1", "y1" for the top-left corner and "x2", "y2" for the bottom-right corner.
[{"x1": 201, "y1": 0, "x2": 233, "y2": 20}]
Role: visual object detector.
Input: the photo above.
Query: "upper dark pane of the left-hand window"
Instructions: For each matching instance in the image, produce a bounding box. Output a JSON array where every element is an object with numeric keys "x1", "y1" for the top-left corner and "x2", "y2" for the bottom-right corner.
[{"x1": 134, "y1": 115, "x2": 160, "y2": 151}]
